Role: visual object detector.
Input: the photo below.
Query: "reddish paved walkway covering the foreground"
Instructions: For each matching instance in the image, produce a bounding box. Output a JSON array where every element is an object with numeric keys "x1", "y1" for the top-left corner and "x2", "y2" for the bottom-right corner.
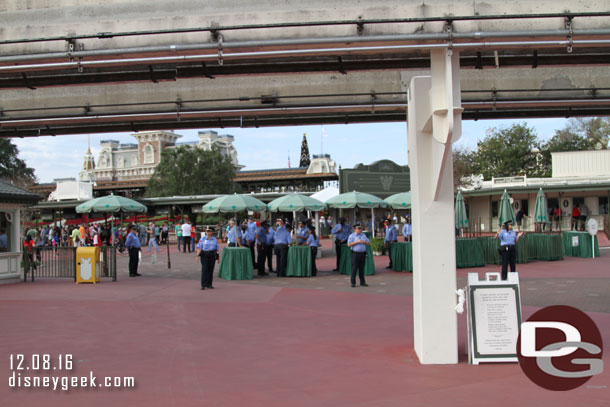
[{"x1": 0, "y1": 237, "x2": 610, "y2": 407}]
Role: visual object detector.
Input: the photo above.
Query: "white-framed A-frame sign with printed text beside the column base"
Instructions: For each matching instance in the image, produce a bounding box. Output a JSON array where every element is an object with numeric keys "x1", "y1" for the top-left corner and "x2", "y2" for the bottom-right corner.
[{"x1": 467, "y1": 273, "x2": 521, "y2": 365}]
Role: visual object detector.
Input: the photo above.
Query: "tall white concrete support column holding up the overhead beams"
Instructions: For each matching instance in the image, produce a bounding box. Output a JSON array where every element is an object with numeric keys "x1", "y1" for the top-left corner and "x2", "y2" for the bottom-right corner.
[{"x1": 407, "y1": 50, "x2": 462, "y2": 364}]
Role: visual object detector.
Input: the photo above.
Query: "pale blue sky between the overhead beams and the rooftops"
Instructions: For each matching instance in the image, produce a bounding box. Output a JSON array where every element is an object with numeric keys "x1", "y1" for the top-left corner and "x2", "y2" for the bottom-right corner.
[{"x1": 13, "y1": 119, "x2": 567, "y2": 183}]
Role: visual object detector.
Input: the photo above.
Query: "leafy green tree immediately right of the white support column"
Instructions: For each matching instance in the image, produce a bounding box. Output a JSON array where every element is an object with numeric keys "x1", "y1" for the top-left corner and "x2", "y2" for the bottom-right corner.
[{"x1": 472, "y1": 123, "x2": 547, "y2": 179}]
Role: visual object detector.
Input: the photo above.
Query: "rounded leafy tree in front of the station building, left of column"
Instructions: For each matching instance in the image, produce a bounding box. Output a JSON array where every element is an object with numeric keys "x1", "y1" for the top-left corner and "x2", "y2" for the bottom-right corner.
[{"x1": 146, "y1": 146, "x2": 235, "y2": 197}]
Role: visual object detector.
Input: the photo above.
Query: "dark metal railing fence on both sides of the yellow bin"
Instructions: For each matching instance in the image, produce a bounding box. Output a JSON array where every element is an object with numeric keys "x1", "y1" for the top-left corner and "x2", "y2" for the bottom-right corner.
[{"x1": 22, "y1": 246, "x2": 117, "y2": 282}]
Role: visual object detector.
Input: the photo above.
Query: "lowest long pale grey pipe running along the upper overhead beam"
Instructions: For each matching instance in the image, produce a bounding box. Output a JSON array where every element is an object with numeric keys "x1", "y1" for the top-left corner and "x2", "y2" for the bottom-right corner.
[{"x1": 0, "y1": 40, "x2": 610, "y2": 73}]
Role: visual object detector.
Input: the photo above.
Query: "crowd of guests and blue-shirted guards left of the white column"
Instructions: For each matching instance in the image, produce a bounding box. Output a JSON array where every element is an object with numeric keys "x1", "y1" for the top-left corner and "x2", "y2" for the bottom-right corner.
[{"x1": 23, "y1": 216, "x2": 411, "y2": 290}]
